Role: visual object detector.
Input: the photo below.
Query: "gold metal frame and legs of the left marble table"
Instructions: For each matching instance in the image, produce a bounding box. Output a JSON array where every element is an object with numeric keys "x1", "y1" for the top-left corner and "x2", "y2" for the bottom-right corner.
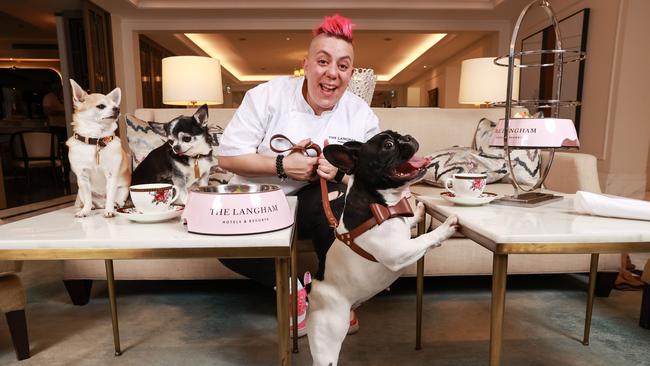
[{"x1": 0, "y1": 203, "x2": 298, "y2": 366}]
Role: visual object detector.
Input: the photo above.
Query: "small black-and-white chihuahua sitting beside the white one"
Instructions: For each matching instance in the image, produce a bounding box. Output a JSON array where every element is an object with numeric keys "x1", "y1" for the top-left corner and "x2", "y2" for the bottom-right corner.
[{"x1": 131, "y1": 104, "x2": 215, "y2": 204}]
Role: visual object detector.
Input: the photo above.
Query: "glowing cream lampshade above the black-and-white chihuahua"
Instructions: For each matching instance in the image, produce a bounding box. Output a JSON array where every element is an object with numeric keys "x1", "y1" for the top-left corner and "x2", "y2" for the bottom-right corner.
[{"x1": 162, "y1": 56, "x2": 223, "y2": 106}]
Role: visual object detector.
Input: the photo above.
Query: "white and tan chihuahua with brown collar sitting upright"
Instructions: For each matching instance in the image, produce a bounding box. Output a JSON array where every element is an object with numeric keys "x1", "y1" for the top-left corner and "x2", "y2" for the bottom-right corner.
[{"x1": 66, "y1": 79, "x2": 131, "y2": 217}]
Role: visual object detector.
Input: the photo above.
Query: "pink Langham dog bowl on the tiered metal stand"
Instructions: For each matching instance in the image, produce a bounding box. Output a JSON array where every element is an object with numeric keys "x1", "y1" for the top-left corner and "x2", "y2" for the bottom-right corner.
[{"x1": 490, "y1": 118, "x2": 580, "y2": 148}]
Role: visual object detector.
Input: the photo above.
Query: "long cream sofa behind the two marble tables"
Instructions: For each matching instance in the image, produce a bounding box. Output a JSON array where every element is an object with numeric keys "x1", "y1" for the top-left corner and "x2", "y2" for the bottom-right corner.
[{"x1": 64, "y1": 108, "x2": 620, "y2": 304}]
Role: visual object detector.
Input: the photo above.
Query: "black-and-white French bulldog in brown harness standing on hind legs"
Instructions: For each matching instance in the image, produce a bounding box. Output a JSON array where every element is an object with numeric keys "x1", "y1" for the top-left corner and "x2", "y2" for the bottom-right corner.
[{"x1": 307, "y1": 131, "x2": 458, "y2": 366}]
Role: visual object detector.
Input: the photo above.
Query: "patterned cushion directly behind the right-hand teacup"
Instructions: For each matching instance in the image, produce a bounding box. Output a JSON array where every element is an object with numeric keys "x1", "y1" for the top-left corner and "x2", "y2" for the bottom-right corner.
[{"x1": 424, "y1": 146, "x2": 508, "y2": 187}]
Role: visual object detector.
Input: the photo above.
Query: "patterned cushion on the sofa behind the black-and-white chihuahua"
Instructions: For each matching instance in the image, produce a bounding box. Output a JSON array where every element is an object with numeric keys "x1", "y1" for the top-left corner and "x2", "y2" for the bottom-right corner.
[{"x1": 126, "y1": 114, "x2": 232, "y2": 184}]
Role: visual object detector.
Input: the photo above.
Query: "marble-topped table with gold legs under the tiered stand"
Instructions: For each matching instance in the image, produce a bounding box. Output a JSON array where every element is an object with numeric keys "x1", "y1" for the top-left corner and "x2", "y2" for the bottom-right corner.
[{"x1": 416, "y1": 195, "x2": 650, "y2": 365}]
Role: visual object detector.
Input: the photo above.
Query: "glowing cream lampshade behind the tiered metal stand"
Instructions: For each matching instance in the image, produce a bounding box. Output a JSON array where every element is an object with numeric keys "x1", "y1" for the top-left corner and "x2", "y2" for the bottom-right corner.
[{"x1": 458, "y1": 57, "x2": 519, "y2": 104}]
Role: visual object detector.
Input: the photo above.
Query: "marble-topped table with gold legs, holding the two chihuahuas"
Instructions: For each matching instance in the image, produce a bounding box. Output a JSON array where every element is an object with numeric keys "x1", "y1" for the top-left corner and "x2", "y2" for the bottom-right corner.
[{"x1": 0, "y1": 197, "x2": 297, "y2": 365}]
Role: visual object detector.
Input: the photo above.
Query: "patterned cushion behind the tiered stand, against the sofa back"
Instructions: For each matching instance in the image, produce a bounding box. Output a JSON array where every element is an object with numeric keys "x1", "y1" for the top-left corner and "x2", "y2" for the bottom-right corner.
[{"x1": 473, "y1": 118, "x2": 542, "y2": 186}]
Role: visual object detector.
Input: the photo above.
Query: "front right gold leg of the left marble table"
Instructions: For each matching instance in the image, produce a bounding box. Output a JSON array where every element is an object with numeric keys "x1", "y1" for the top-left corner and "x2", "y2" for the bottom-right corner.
[{"x1": 275, "y1": 257, "x2": 291, "y2": 366}]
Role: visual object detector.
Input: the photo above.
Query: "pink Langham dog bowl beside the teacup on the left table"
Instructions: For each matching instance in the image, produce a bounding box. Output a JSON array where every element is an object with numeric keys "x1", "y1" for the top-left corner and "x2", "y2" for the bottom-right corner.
[{"x1": 182, "y1": 184, "x2": 293, "y2": 235}]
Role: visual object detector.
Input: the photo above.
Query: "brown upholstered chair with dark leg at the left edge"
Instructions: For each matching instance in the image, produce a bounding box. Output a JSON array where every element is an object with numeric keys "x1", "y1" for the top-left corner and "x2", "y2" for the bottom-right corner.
[{"x1": 0, "y1": 261, "x2": 29, "y2": 360}]
